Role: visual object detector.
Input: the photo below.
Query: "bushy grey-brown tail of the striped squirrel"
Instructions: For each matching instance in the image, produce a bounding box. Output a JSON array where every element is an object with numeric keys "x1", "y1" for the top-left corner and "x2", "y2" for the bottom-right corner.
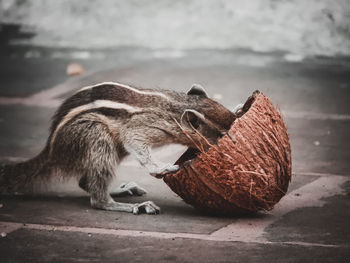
[{"x1": 0, "y1": 147, "x2": 48, "y2": 194}]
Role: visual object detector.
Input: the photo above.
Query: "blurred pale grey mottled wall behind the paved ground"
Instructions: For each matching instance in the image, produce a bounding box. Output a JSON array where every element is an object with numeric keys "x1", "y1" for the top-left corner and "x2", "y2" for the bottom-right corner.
[{"x1": 0, "y1": 0, "x2": 350, "y2": 56}]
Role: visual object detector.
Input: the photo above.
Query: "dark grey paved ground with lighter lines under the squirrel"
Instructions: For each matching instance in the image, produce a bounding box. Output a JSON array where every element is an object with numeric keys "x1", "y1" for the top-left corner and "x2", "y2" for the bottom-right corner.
[{"x1": 0, "y1": 37, "x2": 350, "y2": 262}]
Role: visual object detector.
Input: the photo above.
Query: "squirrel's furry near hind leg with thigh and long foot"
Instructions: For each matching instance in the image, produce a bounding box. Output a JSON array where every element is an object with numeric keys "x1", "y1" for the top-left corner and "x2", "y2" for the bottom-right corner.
[{"x1": 54, "y1": 116, "x2": 160, "y2": 214}]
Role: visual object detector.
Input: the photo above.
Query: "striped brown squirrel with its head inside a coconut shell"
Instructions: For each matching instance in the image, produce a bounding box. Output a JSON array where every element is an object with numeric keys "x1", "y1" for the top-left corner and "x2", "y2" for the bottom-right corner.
[{"x1": 0, "y1": 82, "x2": 240, "y2": 214}]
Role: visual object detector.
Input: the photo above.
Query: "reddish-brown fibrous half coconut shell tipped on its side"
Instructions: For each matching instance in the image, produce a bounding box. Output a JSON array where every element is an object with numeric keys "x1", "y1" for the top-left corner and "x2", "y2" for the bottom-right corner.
[{"x1": 163, "y1": 91, "x2": 292, "y2": 214}]
